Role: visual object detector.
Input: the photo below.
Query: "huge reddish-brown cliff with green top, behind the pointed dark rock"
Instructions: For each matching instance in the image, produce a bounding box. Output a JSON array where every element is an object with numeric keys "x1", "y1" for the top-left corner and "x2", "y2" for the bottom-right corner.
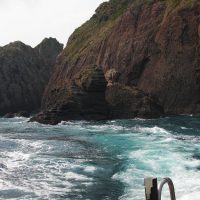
[{"x1": 32, "y1": 0, "x2": 200, "y2": 122}]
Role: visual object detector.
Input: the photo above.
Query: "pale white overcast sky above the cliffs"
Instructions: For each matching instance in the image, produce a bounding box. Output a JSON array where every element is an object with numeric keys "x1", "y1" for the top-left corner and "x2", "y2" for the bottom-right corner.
[{"x1": 0, "y1": 0, "x2": 105, "y2": 47}]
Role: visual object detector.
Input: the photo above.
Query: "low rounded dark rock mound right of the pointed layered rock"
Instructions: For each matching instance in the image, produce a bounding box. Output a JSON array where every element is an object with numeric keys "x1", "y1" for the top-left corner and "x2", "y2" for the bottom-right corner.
[{"x1": 106, "y1": 83, "x2": 163, "y2": 119}]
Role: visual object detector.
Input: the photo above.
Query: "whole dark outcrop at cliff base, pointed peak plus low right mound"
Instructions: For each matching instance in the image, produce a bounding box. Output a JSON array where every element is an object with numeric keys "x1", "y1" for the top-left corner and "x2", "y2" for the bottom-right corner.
[{"x1": 31, "y1": 65, "x2": 163, "y2": 124}]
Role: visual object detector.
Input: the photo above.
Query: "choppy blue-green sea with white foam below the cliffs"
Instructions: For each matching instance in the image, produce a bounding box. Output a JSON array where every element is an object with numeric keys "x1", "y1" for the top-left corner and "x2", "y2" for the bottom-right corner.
[{"x1": 0, "y1": 116, "x2": 200, "y2": 200}]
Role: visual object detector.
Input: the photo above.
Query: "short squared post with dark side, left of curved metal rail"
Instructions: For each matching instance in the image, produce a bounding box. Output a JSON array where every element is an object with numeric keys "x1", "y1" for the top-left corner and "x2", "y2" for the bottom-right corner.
[{"x1": 144, "y1": 177, "x2": 158, "y2": 200}]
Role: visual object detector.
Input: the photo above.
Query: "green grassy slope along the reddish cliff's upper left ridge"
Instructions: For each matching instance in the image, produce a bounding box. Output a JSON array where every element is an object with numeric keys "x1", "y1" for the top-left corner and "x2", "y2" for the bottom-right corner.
[{"x1": 65, "y1": 0, "x2": 134, "y2": 63}]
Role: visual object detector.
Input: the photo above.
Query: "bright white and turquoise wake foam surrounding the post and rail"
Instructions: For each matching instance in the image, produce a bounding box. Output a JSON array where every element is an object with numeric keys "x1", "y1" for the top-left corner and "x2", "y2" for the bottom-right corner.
[{"x1": 113, "y1": 139, "x2": 200, "y2": 200}]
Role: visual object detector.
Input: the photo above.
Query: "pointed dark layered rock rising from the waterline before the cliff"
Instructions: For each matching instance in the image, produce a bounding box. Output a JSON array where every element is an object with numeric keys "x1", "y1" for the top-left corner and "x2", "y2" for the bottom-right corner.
[{"x1": 31, "y1": 65, "x2": 109, "y2": 124}]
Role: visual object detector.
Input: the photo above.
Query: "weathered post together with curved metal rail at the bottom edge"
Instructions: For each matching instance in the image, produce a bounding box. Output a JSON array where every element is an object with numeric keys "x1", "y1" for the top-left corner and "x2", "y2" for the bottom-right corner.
[{"x1": 144, "y1": 178, "x2": 176, "y2": 200}]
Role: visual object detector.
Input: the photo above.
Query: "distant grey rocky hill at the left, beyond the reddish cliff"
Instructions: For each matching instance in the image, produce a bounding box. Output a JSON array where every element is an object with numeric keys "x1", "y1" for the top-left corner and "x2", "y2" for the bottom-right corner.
[{"x1": 0, "y1": 39, "x2": 62, "y2": 115}]
